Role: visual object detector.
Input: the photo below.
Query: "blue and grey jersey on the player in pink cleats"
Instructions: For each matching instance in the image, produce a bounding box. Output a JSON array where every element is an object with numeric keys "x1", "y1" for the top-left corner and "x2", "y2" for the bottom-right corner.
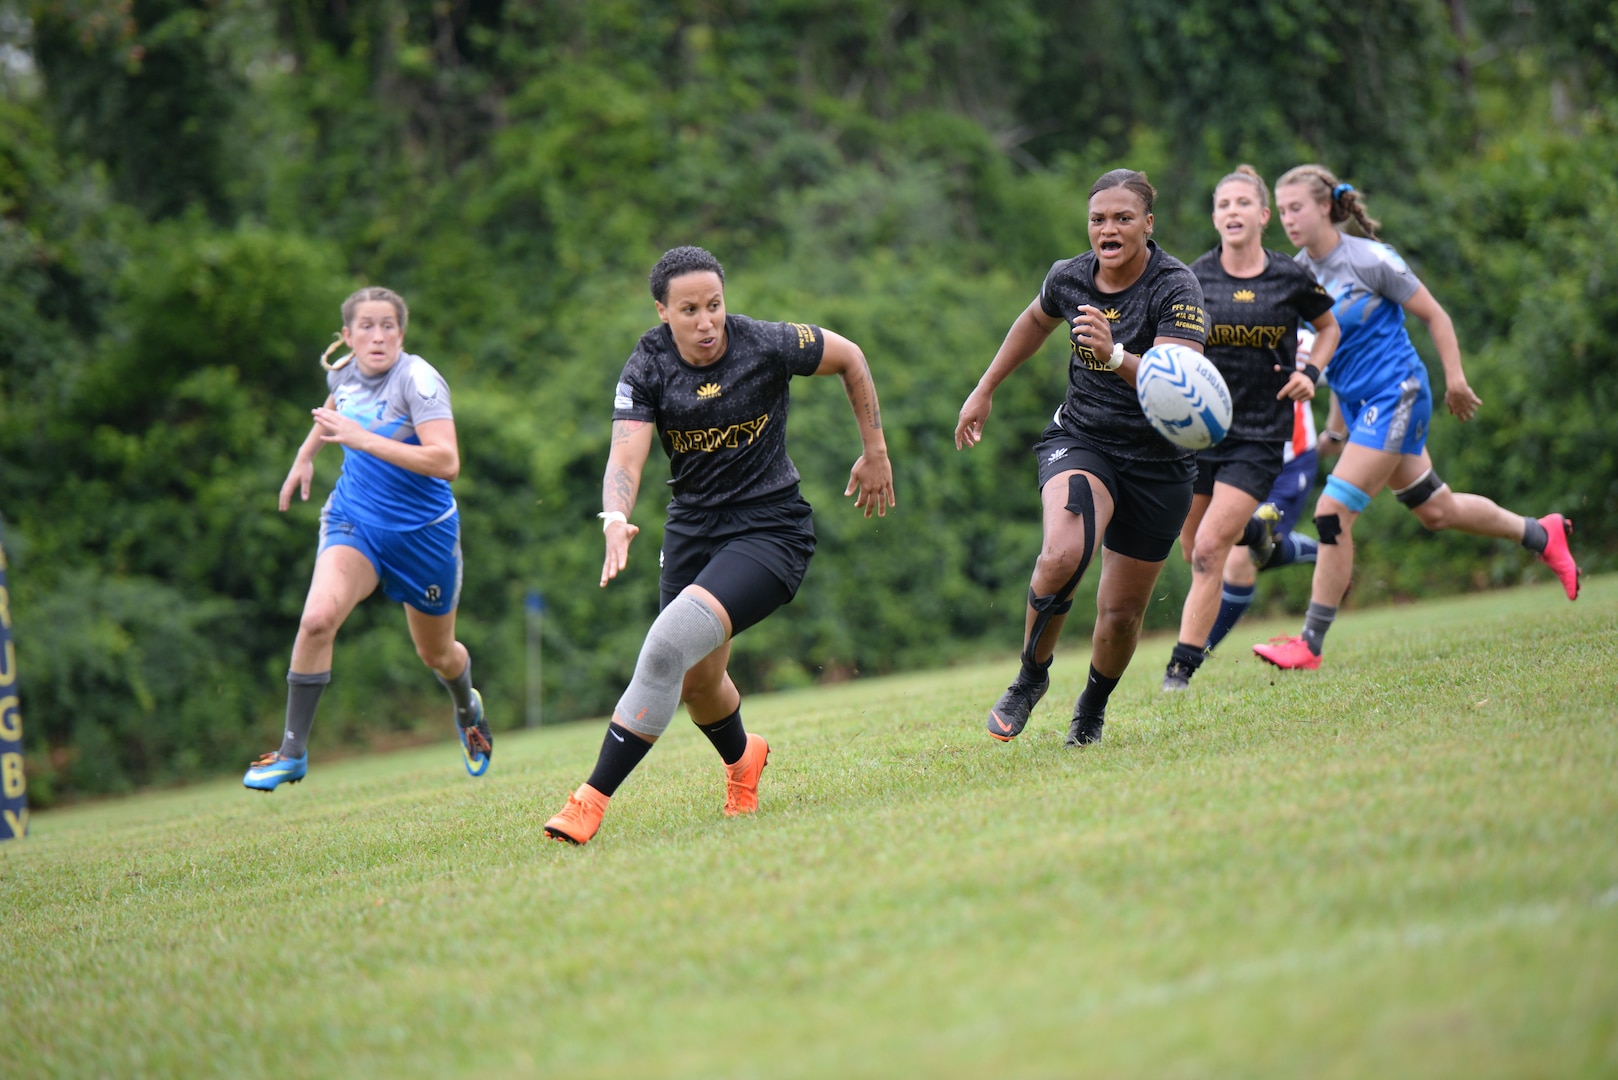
[{"x1": 1296, "y1": 236, "x2": 1422, "y2": 405}]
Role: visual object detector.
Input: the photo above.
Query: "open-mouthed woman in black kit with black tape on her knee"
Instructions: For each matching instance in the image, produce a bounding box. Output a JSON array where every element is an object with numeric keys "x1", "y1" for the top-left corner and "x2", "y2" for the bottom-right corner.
[{"x1": 955, "y1": 168, "x2": 1204, "y2": 746}]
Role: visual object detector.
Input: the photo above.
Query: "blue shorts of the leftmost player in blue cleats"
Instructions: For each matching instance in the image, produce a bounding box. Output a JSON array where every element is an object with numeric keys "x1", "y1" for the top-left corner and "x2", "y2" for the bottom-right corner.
[{"x1": 320, "y1": 502, "x2": 461, "y2": 615}]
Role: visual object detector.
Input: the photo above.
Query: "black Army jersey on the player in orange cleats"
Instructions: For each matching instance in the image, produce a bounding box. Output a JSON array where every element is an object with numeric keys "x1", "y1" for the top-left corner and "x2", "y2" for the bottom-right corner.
[{"x1": 612, "y1": 314, "x2": 825, "y2": 508}]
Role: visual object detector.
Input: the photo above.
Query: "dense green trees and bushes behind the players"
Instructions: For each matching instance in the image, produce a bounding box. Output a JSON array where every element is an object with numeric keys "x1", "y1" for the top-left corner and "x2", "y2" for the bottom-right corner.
[{"x1": 0, "y1": 0, "x2": 1618, "y2": 801}]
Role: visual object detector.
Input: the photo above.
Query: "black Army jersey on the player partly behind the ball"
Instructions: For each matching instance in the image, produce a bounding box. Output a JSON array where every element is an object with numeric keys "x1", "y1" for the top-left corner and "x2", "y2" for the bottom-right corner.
[{"x1": 1191, "y1": 244, "x2": 1332, "y2": 442}]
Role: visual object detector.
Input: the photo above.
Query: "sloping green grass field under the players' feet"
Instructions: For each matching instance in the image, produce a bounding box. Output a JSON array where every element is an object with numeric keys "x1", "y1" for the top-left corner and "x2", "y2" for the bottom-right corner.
[{"x1": 0, "y1": 576, "x2": 1618, "y2": 1078}]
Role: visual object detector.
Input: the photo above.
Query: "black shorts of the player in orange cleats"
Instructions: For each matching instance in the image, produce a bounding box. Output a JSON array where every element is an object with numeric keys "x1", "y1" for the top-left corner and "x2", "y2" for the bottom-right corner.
[{"x1": 659, "y1": 487, "x2": 814, "y2": 636}]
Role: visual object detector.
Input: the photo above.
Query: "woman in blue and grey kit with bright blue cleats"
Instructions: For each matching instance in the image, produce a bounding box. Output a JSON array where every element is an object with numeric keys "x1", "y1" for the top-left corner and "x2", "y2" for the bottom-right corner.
[{"x1": 243, "y1": 288, "x2": 493, "y2": 792}]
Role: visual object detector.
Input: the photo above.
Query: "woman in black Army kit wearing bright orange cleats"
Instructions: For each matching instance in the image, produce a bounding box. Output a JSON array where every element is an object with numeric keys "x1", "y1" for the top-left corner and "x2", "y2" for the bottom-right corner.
[{"x1": 545, "y1": 248, "x2": 895, "y2": 844}]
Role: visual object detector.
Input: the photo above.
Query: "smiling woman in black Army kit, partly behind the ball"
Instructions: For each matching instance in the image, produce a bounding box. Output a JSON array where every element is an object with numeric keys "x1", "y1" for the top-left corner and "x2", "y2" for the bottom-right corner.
[{"x1": 1163, "y1": 165, "x2": 1338, "y2": 690}]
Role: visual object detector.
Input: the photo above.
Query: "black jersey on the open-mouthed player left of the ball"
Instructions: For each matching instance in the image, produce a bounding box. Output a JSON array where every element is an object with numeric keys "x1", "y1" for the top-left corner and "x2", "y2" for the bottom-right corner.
[{"x1": 1039, "y1": 240, "x2": 1205, "y2": 461}]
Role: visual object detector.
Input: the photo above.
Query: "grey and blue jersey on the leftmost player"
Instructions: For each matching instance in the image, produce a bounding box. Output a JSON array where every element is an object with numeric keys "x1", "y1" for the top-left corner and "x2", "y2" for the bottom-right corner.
[{"x1": 325, "y1": 353, "x2": 455, "y2": 531}]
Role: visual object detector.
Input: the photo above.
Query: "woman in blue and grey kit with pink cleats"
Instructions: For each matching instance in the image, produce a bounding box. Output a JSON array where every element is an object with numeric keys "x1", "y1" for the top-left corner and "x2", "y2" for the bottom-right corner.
[{"x1": 1252, "y1": 165, "x2": 1579, "y2": 669}]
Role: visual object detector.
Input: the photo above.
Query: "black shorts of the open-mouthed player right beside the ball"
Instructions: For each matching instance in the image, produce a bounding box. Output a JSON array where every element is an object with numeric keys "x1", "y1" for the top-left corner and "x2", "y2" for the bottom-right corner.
[{"x1": 1034, "y1": 424, "x2": 1196, "y2": 562}]
